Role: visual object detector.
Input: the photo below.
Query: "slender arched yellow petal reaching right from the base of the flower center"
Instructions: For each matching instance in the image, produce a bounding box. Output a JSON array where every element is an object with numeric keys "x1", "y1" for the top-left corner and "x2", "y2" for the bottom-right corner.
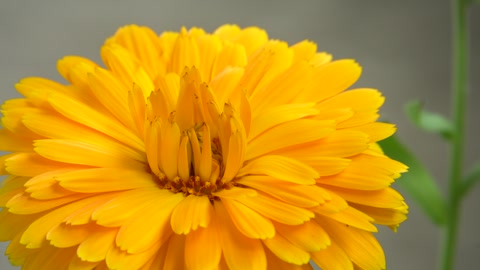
[{"x1": 237, "y1": 155, "x2": 320, "y2": 185}]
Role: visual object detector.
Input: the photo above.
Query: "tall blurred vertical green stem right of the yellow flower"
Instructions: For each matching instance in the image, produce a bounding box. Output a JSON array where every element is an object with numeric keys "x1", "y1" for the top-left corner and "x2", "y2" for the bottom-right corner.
[{"x1": 441, "y1": 0, "x2": 468, "y2": 270}]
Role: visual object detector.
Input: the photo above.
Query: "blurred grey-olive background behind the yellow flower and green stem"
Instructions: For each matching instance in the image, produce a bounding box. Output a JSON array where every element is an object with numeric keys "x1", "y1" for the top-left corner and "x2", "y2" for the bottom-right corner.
[{"x1": 0, "y1": 0, "x2": 480, "y2": 270}]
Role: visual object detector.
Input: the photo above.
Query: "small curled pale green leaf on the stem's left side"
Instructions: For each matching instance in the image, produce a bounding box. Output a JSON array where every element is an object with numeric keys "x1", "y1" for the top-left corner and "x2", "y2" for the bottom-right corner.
[{"x1": 405, "y1": 100, "x2": 454, "y2": 140}]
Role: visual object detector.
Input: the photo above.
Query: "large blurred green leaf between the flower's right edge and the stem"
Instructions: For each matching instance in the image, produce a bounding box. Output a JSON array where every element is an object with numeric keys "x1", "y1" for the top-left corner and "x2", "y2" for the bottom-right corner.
[{"x1": 379, "y1": 136, "x2": 446, "y2": 224}]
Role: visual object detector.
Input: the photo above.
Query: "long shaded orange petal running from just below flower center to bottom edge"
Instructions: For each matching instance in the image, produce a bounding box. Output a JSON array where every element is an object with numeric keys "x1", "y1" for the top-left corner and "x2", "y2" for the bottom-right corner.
[{"x1": 214, "y1": 202, "x2": 267, "y2": 270}]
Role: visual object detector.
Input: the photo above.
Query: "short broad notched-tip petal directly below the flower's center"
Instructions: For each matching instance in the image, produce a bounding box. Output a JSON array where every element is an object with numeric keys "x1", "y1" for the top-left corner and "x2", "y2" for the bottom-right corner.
[{"x1": 170, "y1": 195, "x2": 213, "y2": 234}]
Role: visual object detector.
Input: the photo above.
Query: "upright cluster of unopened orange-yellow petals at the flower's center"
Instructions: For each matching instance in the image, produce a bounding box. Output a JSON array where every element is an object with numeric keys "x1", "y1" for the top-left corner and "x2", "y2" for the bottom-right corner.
[{"x1": 145, "y1": 68, "x2": 246, "y2": 200}]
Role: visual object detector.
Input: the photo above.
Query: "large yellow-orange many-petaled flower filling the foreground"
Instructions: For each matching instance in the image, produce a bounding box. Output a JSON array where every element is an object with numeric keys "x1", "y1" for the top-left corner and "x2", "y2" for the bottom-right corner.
[{"x1": 0, "y1": 25, "x2": 407, "y2": 270}]
